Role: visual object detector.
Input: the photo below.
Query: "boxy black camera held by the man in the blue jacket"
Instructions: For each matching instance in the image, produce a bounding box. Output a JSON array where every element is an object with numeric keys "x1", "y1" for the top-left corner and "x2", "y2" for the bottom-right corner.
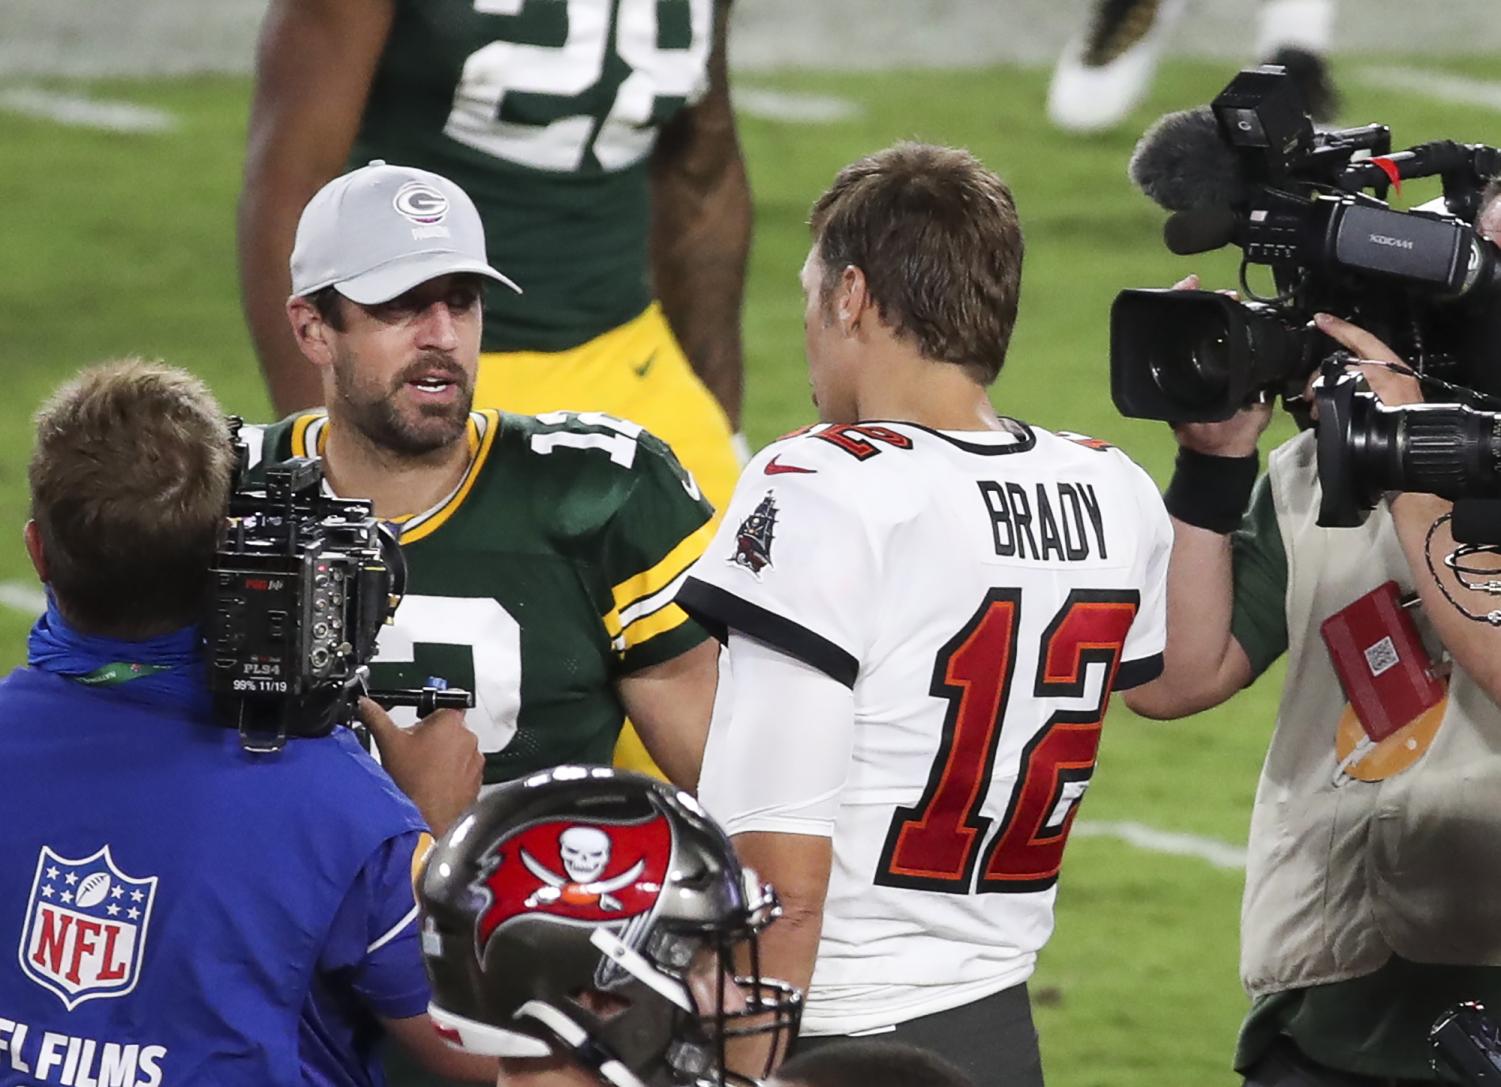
[{"x1": 207, "y1": 417, "x2": 474, "y2": 752}]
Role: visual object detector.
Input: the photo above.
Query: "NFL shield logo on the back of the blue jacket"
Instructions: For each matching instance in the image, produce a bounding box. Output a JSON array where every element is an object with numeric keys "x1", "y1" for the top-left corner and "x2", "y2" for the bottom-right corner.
[{"x1": 21, "y1": 845, "x2": 156, "y2": 1010}]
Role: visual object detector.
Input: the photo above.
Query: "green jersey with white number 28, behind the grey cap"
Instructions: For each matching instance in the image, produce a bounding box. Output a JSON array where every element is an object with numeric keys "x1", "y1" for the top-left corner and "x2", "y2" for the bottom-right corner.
[{"x1": 350, "y1": 0, "x2": 728, "y2": 351}]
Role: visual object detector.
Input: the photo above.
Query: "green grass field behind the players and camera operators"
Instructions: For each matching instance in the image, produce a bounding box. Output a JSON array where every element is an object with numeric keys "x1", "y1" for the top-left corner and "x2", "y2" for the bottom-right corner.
[{"x1": 0, "y1": 59, "x2": 1498, "y2": 1087}]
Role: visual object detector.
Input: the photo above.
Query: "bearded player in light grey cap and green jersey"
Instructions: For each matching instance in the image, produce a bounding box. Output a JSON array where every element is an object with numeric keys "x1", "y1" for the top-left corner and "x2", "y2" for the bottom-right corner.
[{"x1": 252, "y1": 162, "x2": 716, "y2": 810}]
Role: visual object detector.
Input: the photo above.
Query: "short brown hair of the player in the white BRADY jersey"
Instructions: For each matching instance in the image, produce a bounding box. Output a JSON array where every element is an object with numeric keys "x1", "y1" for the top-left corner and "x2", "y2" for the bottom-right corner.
[{"x1": 809, "y1": 143, "x2": 1024, "y2": 384}]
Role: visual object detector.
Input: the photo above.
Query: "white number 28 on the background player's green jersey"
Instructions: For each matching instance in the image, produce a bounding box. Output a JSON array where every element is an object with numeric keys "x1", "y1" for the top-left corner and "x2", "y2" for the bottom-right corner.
[{"x1": 443, "y1": 0, "x2": 713, "y2": 173}]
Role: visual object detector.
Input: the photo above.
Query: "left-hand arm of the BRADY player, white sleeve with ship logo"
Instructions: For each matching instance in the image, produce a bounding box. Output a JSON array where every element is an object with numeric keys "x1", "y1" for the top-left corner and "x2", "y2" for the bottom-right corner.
[{"x1": 678, "y1": 456, "x2": 881, "y2": 1044}]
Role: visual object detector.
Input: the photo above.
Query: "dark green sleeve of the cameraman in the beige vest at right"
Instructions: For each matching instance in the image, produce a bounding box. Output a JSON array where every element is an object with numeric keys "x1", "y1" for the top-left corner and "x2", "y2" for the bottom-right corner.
[{"x1": 1229, "y1": 476, "x2": 1288, "y2": 679}]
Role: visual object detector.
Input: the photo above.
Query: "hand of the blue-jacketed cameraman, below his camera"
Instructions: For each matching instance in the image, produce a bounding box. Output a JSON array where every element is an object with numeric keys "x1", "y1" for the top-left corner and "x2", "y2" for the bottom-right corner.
[{"x1": 359, "y1": 698, "x2": 485, "y2": 835}]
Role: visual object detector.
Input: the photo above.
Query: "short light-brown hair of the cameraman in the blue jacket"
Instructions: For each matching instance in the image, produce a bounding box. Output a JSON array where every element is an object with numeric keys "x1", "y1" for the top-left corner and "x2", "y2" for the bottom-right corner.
[{"x1": 29, "y1": 359, "x2": 233, "y2": 637}]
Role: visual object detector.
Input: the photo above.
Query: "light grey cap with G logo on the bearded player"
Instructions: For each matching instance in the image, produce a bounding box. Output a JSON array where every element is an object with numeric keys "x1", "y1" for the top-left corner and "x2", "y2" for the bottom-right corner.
[{"x1": 291, "y1": 159, "x2": 521, "y2": 306}]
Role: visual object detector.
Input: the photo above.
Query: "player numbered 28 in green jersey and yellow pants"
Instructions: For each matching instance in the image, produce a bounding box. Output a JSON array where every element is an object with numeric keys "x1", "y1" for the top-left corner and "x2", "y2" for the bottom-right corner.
[{"x1": 240, "y1": 0, "x2": 751, "y2": 525}]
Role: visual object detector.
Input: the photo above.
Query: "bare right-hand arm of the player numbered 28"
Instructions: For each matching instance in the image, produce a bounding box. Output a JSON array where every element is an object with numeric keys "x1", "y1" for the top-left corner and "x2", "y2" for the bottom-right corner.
[{"x1": 651, "y1": 0, "x2": 751, "y2": 431}]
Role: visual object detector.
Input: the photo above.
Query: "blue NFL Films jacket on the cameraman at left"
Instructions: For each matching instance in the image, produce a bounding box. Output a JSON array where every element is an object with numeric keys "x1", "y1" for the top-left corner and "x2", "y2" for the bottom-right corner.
[{"x1": 0, "y1": 670, "x2": 423, "y2": 1087}]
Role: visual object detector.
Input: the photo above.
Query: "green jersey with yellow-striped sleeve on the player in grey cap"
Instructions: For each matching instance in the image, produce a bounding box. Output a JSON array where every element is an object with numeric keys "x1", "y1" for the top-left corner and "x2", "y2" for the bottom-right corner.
[{"x1": 248, "y1": 411, "x2": 711, "y2": 782}]
